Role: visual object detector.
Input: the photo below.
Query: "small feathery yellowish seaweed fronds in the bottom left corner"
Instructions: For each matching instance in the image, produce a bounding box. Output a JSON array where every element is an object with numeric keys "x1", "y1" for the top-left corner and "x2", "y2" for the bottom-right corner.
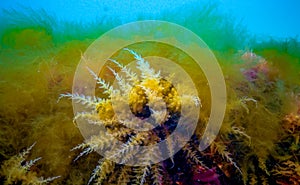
[{"x1": 0, "y1": 143, "x2": 60, "y2": 185}]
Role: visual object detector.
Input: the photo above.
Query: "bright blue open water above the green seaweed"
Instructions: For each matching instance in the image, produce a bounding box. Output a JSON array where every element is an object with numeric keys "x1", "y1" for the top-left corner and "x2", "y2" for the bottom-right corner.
[{"x1": 0, "y1": 0, "x2": 300, "y2": 38}]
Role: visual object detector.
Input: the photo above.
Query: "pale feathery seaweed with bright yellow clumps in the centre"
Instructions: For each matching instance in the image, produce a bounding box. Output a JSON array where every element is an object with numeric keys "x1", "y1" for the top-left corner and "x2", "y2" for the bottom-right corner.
[{"x1": 61, "y1": 49, "x2": 200, "y2": 184}]
